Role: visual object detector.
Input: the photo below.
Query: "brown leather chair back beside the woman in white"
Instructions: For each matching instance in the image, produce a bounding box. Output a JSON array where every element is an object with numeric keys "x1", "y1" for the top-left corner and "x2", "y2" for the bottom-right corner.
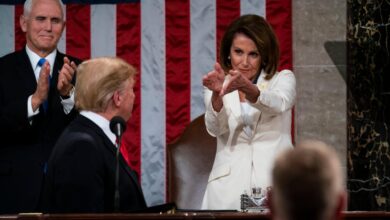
[{"x1": 167, "y1": 114, "x2": 217, "y2": 209}]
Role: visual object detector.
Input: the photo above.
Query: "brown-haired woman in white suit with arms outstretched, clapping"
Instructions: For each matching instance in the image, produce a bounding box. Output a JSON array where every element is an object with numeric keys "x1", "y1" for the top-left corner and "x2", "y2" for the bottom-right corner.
[{"x1": 202, "y1": 15, "x2": 296, "y2": 210}]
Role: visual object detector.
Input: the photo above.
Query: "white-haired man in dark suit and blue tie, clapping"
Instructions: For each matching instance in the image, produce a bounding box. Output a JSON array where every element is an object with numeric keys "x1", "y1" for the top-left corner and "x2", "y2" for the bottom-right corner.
[{"x1": 0, "y1": 0, "x2": 79, "y2": 213}]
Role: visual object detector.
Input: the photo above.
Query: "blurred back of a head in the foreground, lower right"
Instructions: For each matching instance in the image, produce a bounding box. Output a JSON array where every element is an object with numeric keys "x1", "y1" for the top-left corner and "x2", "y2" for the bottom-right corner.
[{"x1": 271, "y1": 140, "x2": 345, "y2": 220}]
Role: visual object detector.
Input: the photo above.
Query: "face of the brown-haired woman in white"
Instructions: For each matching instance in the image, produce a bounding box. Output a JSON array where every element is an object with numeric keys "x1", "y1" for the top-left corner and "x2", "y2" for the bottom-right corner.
[{"x1": 230, "y1": 33, "x2": 261, "y2": 80}]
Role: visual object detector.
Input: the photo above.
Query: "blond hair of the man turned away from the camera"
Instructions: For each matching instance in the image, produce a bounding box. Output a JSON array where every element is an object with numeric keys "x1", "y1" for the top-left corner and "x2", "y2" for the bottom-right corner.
[{"x1": 75, "y1": 57, "x2": 136, "y2": 112}]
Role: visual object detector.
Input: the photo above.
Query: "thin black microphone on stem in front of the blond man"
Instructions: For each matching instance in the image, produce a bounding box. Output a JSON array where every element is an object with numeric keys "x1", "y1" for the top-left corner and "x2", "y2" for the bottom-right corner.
[{"x1": 110, "y1": 116, "x2": 126, "y2": 212}]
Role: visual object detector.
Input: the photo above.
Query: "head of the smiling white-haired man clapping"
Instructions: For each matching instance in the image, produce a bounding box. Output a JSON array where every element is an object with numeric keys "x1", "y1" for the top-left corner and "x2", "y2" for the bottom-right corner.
[{"x1": 20, "y1": 0, "x2": 65, "y2": 56}]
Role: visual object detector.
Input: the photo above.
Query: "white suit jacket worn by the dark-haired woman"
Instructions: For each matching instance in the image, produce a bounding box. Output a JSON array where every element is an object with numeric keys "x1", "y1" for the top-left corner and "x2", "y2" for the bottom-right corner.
[{"x1": 202, "y1": 70, "x2": 296, "y2": 210}]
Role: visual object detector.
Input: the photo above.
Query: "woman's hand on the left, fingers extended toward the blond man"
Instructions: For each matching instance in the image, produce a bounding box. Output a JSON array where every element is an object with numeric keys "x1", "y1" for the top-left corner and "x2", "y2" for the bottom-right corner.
[{"x1": 203, "y1": 63, "x2": 225, "y2": 94}]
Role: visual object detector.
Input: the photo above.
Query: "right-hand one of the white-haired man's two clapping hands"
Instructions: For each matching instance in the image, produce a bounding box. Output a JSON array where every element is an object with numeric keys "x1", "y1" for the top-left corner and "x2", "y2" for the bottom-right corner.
[{"x1": 57, "y1": 57, "x2": 77, "y2": 96}]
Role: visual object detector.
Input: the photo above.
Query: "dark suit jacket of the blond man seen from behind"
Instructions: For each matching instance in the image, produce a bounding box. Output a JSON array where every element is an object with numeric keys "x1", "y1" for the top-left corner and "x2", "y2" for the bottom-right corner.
[{"x1": 44, "y1": 115, "x2": 146, "y2": 213}]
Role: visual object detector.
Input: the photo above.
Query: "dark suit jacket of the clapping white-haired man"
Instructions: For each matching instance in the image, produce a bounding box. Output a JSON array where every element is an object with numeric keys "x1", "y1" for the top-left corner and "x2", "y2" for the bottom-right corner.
[{"x1": 0, "y1": 48, "x2": 80, "y2": 213}]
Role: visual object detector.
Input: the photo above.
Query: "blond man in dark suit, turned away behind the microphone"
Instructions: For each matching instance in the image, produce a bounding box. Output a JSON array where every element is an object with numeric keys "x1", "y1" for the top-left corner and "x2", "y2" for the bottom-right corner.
[{"x1": 44, "y1": 57, "x2": 146, "y2": 213}]
